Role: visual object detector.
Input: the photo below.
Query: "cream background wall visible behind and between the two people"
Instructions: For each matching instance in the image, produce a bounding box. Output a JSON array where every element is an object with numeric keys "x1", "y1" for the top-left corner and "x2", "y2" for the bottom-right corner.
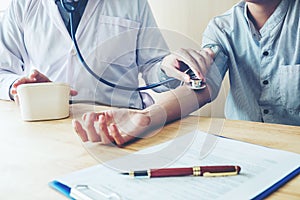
[{"x1": 0, "y1": 0, "x2": 239, "y2": 117}]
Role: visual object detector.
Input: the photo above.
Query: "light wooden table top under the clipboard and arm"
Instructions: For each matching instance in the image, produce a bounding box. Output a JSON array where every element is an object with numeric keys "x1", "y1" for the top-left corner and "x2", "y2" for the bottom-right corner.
[{"x1": 0, "y1": 101, "x2": 300, "y2": 200}]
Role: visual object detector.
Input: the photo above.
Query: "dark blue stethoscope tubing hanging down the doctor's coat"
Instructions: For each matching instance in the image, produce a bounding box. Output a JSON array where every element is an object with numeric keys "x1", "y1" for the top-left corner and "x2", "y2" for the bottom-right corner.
[{"x1": 60, "y1": 0, "x2": 177, "y2": 91}]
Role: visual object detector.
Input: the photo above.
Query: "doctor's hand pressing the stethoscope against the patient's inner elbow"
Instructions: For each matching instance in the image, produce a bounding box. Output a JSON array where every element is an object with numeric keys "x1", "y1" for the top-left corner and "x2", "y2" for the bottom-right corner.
[{"x1": 161, "y1": 48, "x2": 214, "y2": 83}]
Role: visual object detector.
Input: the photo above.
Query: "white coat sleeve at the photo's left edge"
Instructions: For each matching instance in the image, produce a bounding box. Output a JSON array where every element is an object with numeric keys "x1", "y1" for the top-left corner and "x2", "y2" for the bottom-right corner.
[{"x1": 0, "y1": 0, "x2": 26, "y2": 100}]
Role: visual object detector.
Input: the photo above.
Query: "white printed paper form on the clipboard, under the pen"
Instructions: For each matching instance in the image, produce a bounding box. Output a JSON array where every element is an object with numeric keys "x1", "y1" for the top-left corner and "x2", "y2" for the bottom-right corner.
[{"x1": 58, "y1": 131, "x2": 300, "y2": 200}]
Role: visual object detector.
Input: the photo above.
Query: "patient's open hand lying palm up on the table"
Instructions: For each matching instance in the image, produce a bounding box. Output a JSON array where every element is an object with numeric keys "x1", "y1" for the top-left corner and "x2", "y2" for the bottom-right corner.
[{"x1": 73, "y1": 109, "x2": 150, "y2": 147}]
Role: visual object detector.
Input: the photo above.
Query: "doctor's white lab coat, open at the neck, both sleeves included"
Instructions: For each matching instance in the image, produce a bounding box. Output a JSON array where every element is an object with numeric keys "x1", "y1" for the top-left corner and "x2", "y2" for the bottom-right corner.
[{"x1": 0, "y1": 0, "x2": 168, "y2": 108}]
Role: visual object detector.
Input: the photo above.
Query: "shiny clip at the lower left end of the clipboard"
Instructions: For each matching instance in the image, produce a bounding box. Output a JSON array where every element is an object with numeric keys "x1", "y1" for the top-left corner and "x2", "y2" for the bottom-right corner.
[{"x1": 70, "y1": 185, "x2": 122, "y2": 200}]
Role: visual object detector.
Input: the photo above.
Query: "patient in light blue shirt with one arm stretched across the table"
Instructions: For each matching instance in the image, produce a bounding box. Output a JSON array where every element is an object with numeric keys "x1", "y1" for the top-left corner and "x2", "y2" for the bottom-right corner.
[{"x1": 73, "y1": 0, "x2": 300, "y2": 146}]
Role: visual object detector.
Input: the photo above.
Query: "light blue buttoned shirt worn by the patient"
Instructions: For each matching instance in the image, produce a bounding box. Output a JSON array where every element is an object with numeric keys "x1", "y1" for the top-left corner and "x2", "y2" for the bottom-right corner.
[{"x1": 203, "y1": 0, "x2": 300, "y2": 125}]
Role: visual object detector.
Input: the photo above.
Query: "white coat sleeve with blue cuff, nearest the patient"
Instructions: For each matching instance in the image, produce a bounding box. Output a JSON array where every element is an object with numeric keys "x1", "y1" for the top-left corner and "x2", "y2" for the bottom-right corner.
[{"x1": 137, "y1": 1, "x2": 180, "y2": 92}]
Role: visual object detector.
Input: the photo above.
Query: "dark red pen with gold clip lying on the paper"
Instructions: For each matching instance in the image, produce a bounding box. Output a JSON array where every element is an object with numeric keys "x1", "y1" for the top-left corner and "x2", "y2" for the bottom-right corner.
[{"x1": 121, "y1": 165, "x2": 241, "y2": 178}]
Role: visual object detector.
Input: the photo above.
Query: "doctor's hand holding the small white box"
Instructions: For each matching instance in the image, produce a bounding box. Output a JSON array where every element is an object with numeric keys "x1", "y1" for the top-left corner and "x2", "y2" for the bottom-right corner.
[{"x1": 10, "y1": 70, "x2": 77, "y2": 102}]
